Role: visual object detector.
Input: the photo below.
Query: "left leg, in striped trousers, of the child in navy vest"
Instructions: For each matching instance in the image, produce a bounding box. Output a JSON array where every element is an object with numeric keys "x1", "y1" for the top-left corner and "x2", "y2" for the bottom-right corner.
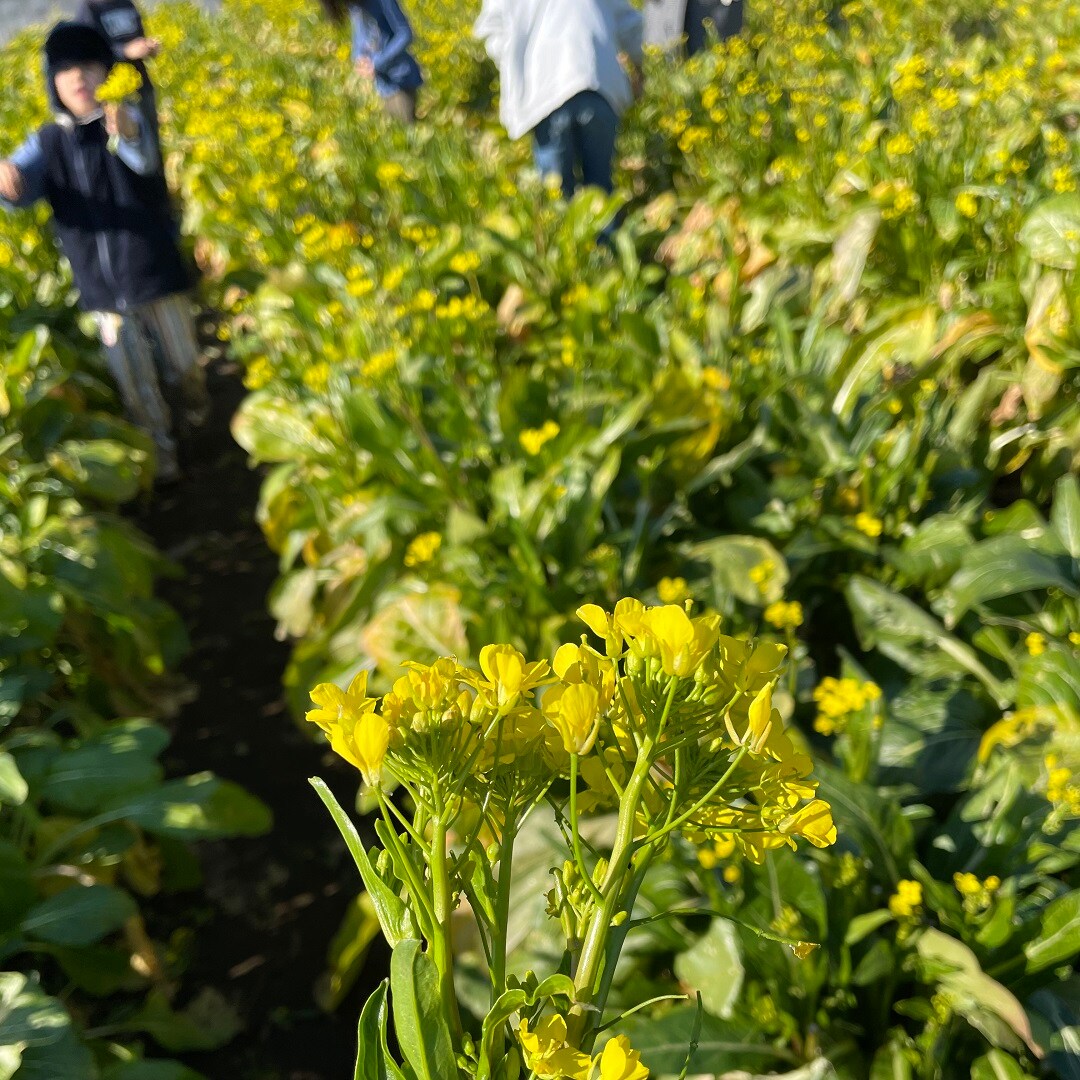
[{"x1": 94, "y1": 312, "x2": 180, "y2": 481}]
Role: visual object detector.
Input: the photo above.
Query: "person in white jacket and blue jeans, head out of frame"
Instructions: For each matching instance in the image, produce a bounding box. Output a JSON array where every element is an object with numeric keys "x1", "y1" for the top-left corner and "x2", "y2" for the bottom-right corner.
[{"x1": 473, "y1": 0, "x2": 642, "y2": 199}]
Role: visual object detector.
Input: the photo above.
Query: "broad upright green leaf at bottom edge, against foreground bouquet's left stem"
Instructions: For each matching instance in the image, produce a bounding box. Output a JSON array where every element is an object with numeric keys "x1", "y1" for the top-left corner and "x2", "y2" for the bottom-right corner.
[{"x1": 390, "y1": 939, "x2": 458, "y2": 1080}]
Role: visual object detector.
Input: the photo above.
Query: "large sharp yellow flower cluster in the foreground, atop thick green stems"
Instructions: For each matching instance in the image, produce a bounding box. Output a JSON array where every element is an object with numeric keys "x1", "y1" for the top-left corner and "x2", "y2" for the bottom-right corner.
[{"x1": 308, "y1": 599, "x2": 836, "y2": 862}]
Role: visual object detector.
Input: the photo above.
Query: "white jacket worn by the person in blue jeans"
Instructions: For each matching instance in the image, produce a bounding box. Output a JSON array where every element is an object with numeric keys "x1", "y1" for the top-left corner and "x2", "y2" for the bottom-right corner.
[{"x1": 473, "y1": 0, "x2": 642, "y2": 138}]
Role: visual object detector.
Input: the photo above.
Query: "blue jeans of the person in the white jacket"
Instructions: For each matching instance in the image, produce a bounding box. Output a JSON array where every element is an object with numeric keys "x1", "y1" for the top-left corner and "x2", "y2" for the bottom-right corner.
[{"x1": 532, "y1": 90, "x2": 619, "y2": 199}]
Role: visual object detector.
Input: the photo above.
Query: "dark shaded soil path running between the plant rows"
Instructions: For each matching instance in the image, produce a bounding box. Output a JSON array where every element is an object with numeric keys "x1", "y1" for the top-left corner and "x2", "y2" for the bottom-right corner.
[{"x1": 139, "y1": 361, "x2": 384, "y2": 1080}]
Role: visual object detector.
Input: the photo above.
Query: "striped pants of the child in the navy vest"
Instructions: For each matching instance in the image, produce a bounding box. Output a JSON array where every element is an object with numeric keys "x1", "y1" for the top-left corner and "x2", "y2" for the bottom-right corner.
[{"x1": 94, "y1": 294, "x2": 210, "y2": 480}]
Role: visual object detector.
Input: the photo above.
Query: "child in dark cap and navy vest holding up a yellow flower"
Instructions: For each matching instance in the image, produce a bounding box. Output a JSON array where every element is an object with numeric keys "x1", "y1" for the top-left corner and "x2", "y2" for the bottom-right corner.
[{"x1": 0, "y1": 23, "x2": 210, "y2": 482}]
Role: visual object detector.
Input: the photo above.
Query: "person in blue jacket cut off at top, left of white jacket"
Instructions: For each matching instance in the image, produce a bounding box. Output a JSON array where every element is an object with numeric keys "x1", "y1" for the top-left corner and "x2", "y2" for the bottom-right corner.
[{"x1": 322, "y1": 0, "x2": 423, "y2": 124}]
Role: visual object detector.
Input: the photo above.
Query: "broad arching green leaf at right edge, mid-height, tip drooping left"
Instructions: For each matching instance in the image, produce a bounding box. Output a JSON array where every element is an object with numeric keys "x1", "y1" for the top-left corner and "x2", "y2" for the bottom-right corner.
[{"x1": 941, "y1": 536, "x2": 1080, "y2": 627}]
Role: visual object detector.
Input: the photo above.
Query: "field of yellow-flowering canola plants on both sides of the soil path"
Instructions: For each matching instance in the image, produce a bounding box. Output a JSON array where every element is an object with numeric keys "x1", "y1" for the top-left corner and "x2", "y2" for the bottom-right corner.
[{"x1": 0, "y1": 0, "x2": 1080, "y2": 1080}]
